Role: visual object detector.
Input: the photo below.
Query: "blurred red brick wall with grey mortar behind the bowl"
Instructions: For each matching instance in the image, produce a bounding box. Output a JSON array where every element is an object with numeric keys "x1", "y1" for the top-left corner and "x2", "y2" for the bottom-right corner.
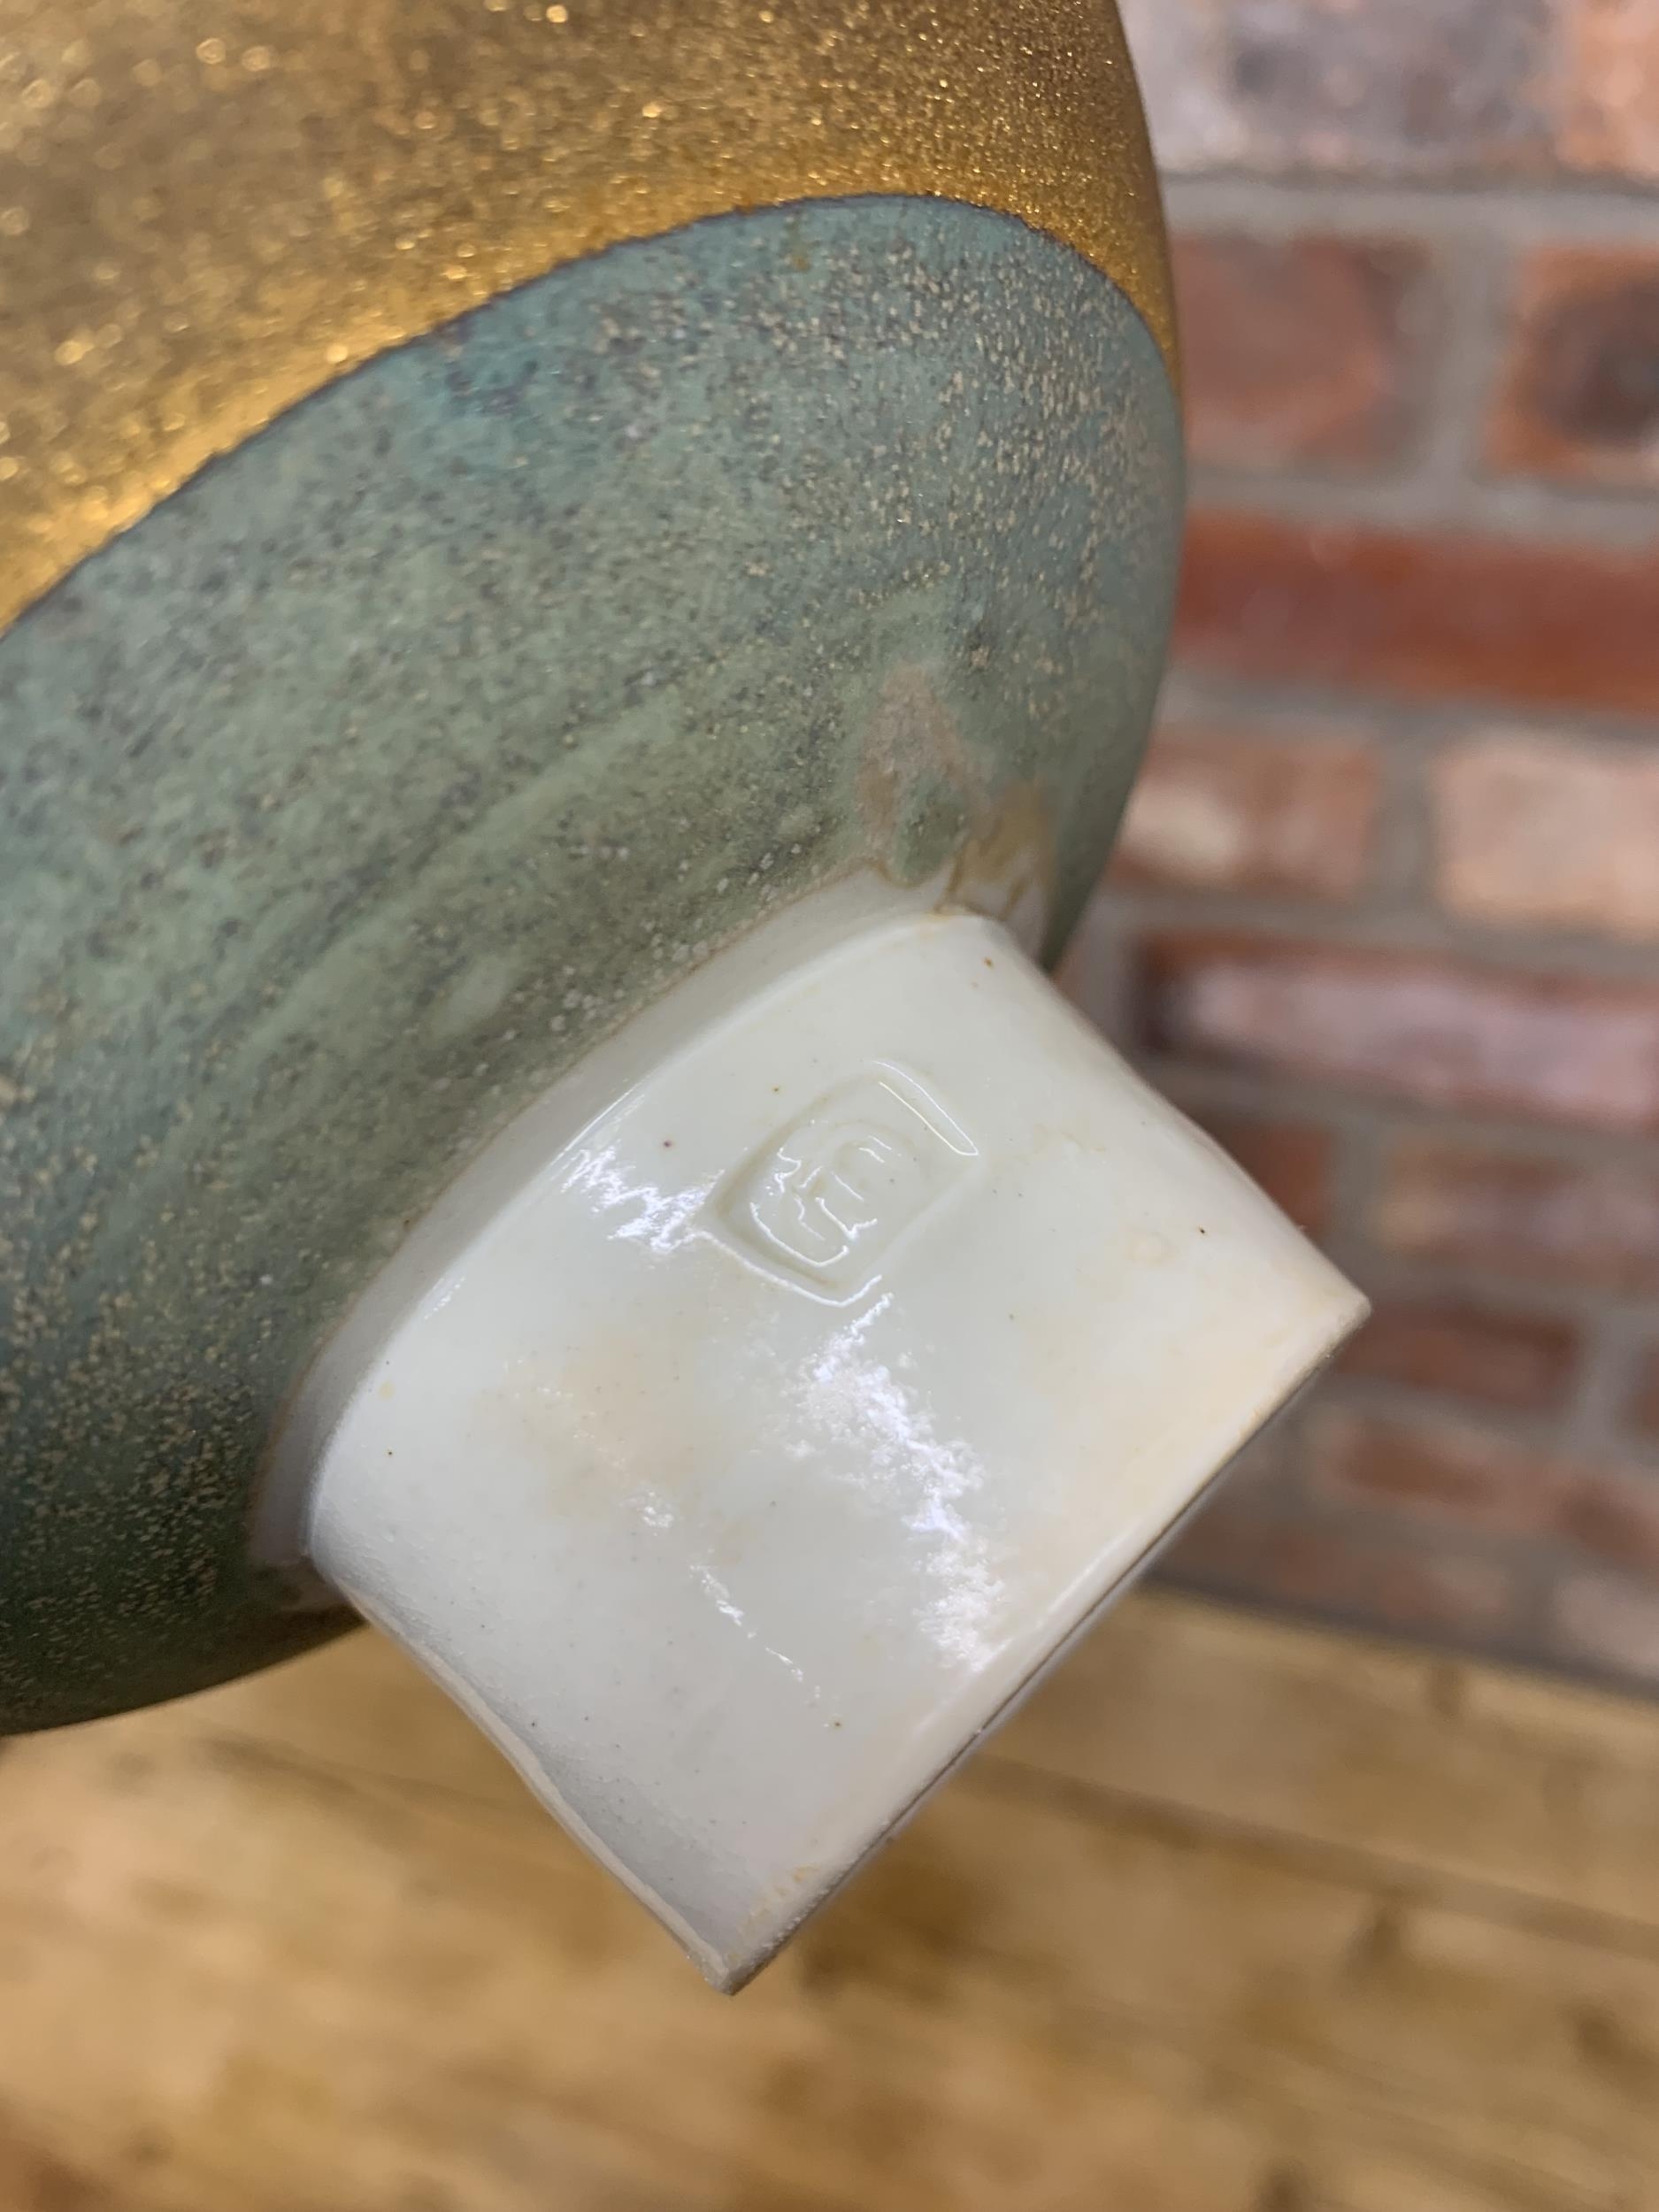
[{"x1": 1071, "y1": 0, "x2": 1659, "y2": 1686}]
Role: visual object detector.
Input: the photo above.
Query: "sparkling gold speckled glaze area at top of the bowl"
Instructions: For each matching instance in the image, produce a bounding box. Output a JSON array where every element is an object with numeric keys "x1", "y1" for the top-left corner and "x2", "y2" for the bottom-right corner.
[{"x1": 0, "y1": 0, "x2": 1172, "y2": 624}]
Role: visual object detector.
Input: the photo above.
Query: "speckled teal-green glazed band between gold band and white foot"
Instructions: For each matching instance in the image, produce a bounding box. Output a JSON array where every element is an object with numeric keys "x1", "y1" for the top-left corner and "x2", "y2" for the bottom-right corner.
[{"x1": 0, "y1": 199, "x2": 1179, "y2": 1728}]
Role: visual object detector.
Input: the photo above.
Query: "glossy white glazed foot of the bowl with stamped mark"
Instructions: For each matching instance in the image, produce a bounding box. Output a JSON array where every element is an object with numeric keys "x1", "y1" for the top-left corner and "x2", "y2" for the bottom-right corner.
[{"x1": 286, "y1": 914, "x2": 1365, "y2": 1989}]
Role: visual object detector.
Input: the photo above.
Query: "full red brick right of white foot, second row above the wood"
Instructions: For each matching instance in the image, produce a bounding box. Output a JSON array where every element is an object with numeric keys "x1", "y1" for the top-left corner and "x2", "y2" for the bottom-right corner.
[{"x1": 1308, "y1": 1405, "x2": 1584, "y2": 1535}]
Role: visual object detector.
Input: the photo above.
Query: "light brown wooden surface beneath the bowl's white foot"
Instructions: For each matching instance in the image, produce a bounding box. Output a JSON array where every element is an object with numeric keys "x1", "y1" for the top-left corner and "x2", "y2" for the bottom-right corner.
[{"x1": 0, "y1": 1597, "x2": 1659, "y2": 2212}]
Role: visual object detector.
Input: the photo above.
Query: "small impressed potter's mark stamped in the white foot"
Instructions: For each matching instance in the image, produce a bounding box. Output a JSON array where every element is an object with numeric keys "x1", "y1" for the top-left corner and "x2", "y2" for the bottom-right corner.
[{"x1": 715, "y1": 1064, "x2": 978, "y2": 1303}]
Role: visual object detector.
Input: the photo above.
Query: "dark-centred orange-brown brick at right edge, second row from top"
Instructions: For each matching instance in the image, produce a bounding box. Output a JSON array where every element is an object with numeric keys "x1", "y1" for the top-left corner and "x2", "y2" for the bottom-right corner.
[{"x1": 1486, "y1": 250, "x2": 1659, "y2": 489}]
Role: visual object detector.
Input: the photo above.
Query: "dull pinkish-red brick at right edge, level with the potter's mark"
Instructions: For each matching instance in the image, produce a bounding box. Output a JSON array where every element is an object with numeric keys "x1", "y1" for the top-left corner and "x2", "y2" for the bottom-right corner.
[{"x1": 1371, "y1": 1137, "x2": 1659, "y2": 1292}]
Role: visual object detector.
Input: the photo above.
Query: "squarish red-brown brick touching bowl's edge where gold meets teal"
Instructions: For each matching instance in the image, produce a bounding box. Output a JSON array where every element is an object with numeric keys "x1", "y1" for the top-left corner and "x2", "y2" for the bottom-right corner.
[{"x1": 1175, "y1": 233, "x2": 1429, "y2": 473}]
